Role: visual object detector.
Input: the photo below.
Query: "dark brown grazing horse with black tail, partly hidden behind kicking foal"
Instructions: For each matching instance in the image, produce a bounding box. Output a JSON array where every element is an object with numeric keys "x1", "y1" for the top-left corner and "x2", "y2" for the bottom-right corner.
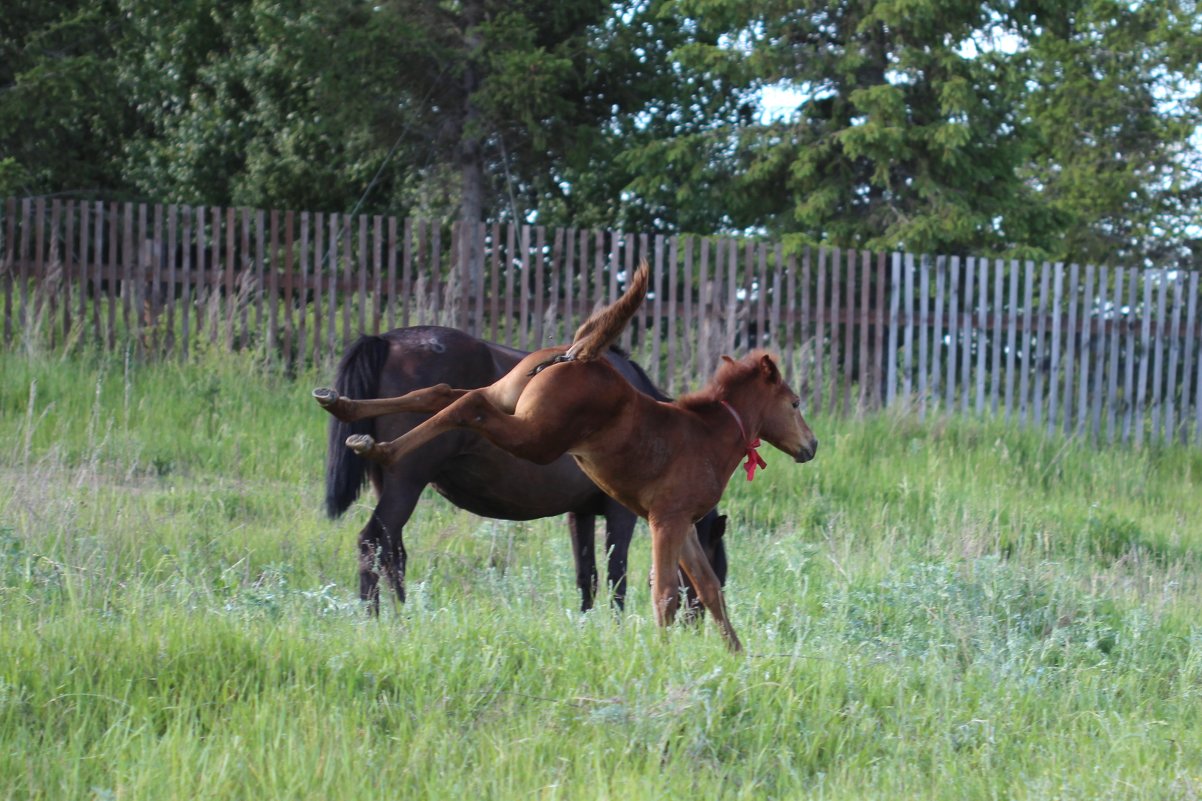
[{"x1": 326, "y1": 326, "x2": 726, "y2": 611}]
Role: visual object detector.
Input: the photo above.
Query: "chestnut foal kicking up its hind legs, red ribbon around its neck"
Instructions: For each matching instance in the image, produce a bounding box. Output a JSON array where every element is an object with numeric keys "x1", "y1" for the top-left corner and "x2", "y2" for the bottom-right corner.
[{"x1": 314, "y1": 263, "x2": 817, "y2": 651}]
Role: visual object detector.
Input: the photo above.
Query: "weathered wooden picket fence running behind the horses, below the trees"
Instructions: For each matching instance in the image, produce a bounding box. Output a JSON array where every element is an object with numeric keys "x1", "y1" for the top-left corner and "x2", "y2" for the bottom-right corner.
[{"x1": 7, "y1": 192, "x2": 1202, "y2": 444}]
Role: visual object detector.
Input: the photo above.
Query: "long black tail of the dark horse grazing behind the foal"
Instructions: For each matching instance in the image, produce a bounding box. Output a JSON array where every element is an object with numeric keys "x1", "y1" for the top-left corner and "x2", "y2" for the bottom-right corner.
[{"x1": 326, "y1": 336, "x2": 389, "y2": 517}]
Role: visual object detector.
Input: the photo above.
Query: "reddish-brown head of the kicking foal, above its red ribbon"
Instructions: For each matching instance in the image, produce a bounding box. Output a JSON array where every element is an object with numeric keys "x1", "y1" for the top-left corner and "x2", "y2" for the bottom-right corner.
[{"x1": 719, "y1": 351, "x2": 819, "y2": 462}]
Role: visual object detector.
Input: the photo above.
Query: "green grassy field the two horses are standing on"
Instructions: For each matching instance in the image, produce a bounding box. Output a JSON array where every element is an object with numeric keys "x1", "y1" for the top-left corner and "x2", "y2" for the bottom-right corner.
[{"x1": 0, "y1": 343, "x2": 1202, "y2": 800}]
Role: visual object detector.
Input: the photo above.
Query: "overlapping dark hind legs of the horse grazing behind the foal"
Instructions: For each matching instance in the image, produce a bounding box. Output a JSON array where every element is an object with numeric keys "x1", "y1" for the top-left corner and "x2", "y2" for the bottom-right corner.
[{"x1": 359, "y1": 479, "x2": 424, "y2": 615}]
